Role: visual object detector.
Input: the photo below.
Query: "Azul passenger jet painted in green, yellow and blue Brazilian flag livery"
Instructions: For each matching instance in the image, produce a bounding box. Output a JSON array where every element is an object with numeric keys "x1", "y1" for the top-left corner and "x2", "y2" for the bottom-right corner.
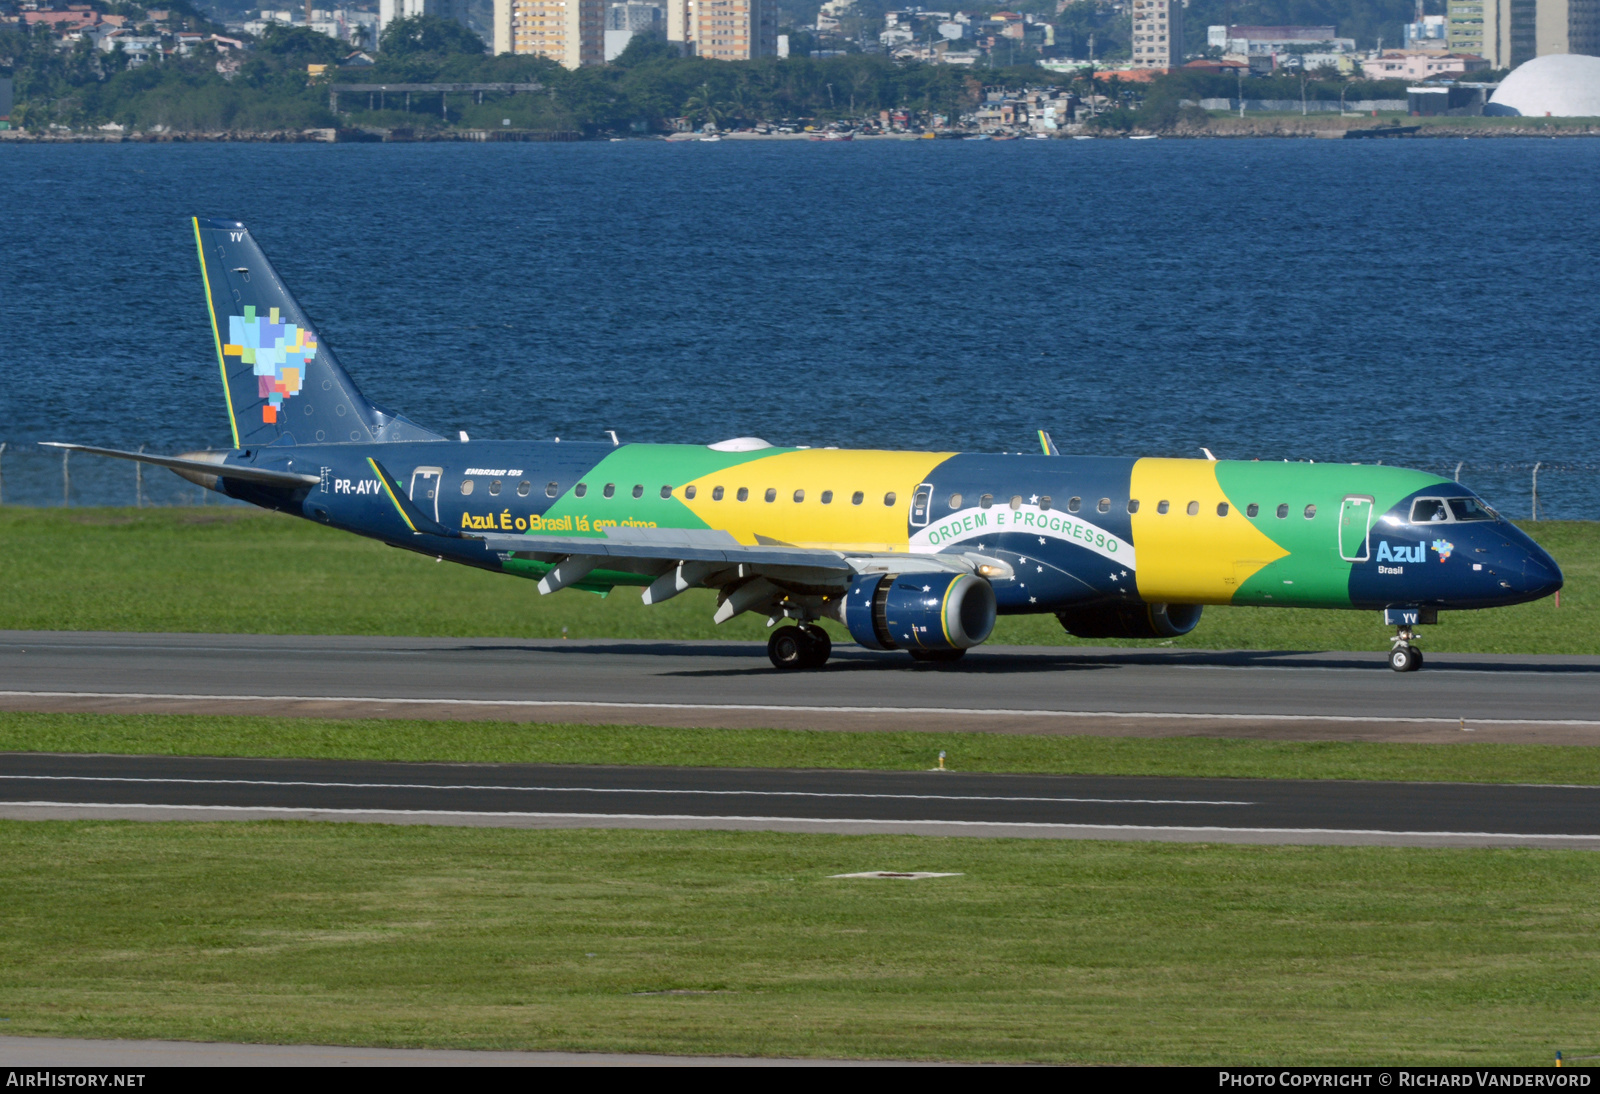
[{"x1": 46, "y1": 218, "x2": 1562, "y2": 672}]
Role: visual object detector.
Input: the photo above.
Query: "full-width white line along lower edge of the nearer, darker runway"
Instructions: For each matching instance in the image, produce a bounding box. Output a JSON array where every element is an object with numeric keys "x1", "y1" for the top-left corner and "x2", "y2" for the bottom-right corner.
[{"x1": 0, "y1": 801, "x2": 1600, "y2": 843}]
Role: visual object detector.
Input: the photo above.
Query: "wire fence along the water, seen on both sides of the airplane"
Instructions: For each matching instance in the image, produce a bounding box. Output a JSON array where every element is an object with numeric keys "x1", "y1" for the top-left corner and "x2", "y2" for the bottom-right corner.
[{"x1": 0, "y1": 441, "x2": 1600, "y2": 520}]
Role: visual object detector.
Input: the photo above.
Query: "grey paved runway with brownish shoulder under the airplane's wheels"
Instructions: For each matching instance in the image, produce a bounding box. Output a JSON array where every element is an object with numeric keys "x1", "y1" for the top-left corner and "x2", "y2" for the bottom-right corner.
[{"x1": 0, "y1": 632, "x2": 1600, "y2": 744}]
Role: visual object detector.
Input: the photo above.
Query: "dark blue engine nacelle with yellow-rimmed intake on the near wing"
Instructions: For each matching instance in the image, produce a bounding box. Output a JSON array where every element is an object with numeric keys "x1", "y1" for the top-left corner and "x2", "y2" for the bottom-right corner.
[{"x1": 843, "y1": 574, "x2": 995, "y2": 649}]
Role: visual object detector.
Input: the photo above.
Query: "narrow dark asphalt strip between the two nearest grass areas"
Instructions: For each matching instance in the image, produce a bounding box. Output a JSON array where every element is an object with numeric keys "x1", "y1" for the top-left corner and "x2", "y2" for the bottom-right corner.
[{"x1": 0, "y1": 753, "x2": 1600, "y2": 849}]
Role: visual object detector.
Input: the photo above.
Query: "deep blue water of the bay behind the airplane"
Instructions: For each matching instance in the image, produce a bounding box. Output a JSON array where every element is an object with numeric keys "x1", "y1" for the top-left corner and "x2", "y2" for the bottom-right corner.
[{"x1": 0, "y1": 139, "x2": 1600, "y2": 518}]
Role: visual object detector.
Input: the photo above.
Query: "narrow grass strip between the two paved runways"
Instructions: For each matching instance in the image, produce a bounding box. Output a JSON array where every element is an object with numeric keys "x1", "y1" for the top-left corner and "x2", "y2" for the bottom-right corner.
[{"x1": 0, "y1": 713, "x2": 1600, "y2": 785}]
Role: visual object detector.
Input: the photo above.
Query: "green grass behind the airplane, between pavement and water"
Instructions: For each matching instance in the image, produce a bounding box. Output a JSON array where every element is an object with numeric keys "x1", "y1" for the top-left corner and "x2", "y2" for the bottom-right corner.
[{"x1": 0, "y1": 507, "x2": 1600, "y2": 654}]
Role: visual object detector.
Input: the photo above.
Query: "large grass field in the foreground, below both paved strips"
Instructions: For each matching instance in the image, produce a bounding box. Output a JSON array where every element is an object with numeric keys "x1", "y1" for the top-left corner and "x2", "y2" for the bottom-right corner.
[{"x1": 0, "y1": 822, "x2": 1600, "y2": 1065}]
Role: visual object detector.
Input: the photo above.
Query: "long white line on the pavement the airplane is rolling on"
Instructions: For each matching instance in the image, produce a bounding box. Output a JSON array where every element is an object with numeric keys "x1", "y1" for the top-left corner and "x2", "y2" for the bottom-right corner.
[{"x1": 0, "y1": 691, "x2": 1600, "y2": 728}]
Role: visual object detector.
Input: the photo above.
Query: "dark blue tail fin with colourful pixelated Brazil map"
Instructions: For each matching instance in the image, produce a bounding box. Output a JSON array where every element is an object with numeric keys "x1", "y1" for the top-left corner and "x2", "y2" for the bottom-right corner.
[{"x1": 194, "y1": 218, "x2": 443, "y2": 448}]
